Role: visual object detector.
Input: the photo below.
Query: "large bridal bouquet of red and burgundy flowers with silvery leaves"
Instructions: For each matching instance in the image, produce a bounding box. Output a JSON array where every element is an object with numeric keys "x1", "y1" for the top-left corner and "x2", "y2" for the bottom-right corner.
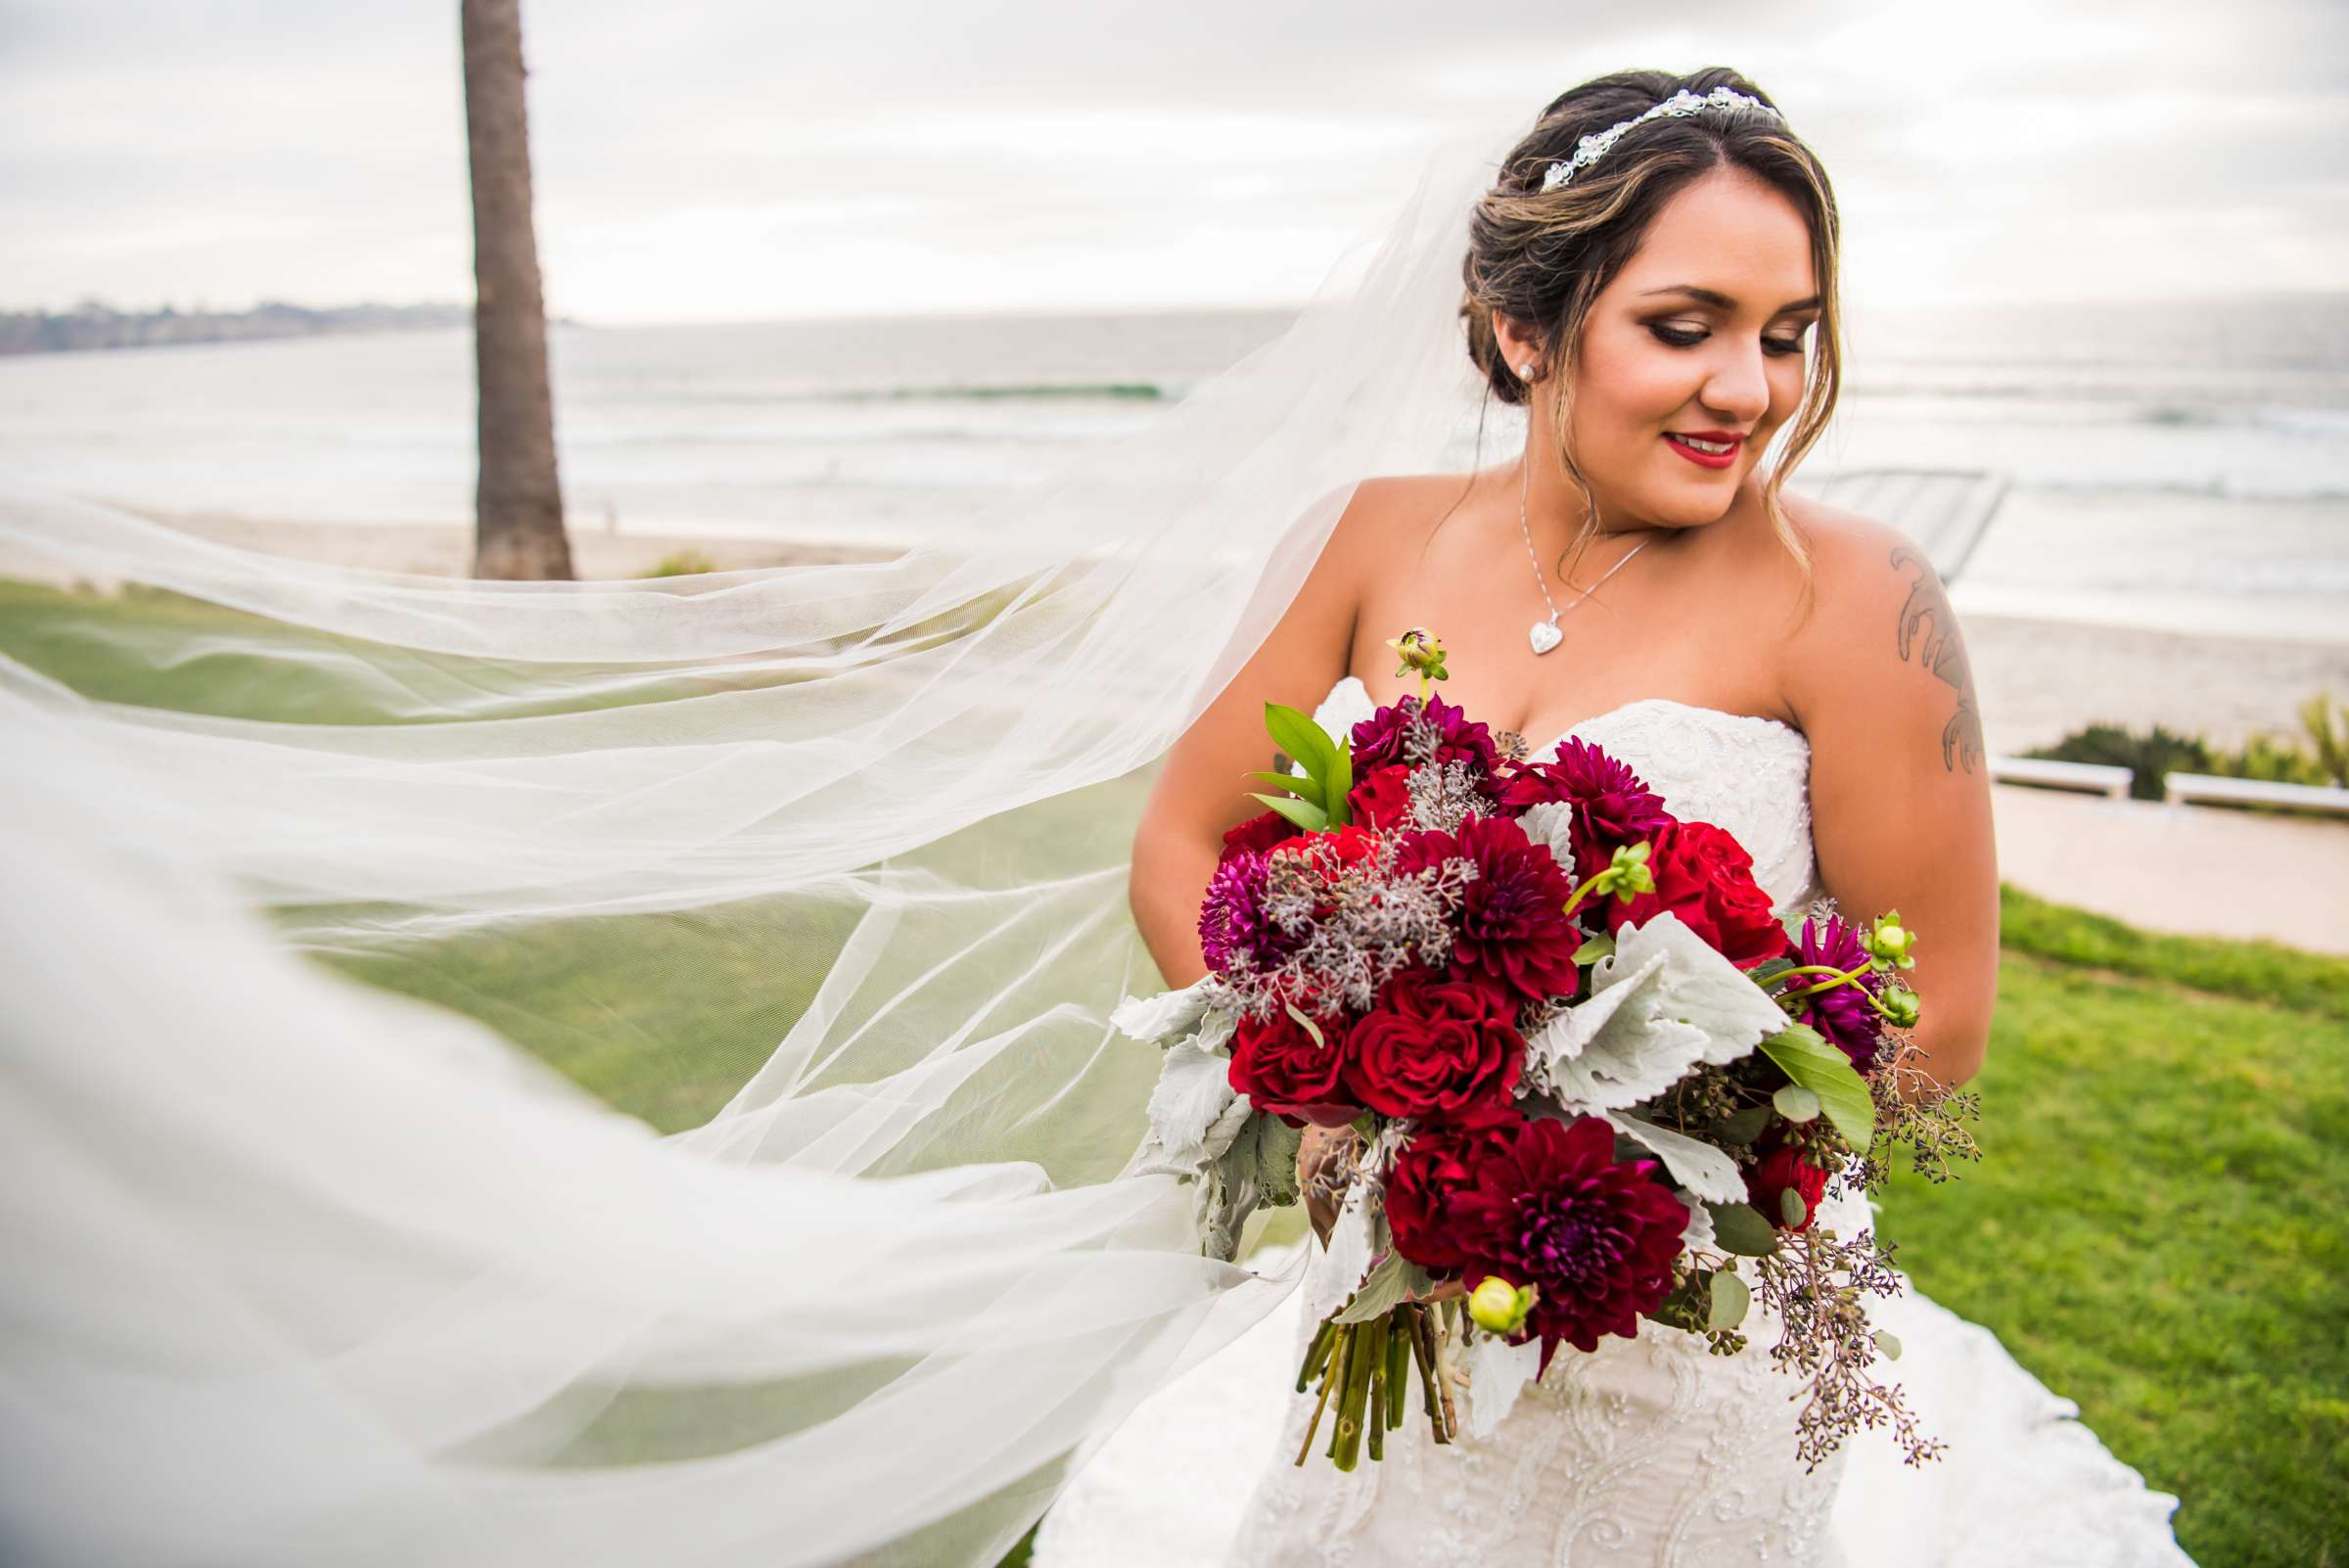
[{"x1": 1114, "y1": 631, "x2": 1975, "y2": 1469}]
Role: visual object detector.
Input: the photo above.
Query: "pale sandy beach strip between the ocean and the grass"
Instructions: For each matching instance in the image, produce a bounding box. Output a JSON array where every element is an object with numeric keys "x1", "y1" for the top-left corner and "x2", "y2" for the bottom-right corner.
[{"x1": 0, "y1": 499, "x2": 2349, "y2": 754}]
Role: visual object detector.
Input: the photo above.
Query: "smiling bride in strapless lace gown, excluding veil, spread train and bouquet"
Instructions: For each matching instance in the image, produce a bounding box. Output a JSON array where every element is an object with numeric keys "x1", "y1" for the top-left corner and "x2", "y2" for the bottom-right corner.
[{"x1": 1132, "y1": 72, "x2": 1999, "y2": 1566}]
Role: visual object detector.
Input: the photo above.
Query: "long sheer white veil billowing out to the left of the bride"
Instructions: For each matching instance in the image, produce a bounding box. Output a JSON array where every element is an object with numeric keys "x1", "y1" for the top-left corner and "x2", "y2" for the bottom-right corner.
[{"x1": 0, "y1": 113, "x2": 1522, "y2": 1568}]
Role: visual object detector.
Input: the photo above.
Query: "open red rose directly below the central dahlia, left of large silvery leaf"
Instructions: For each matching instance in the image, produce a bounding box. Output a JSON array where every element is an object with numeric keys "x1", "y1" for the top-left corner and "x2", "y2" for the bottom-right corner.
[{"x1": 1346, "y1": 969, "x2": 1525, "y2": 1118}]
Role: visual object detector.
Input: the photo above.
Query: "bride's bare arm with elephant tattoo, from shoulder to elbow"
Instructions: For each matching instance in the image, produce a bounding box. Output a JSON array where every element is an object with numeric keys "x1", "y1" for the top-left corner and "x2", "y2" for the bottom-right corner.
[{"x1": 1787, "y1": 514, "x2": 1999, "y2": 1086}]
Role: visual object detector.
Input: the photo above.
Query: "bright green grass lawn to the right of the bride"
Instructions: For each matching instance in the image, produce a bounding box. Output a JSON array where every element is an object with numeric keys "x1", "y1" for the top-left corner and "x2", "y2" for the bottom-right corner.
[{"x1": 1886, "y1": 890, "x2": 2349, "y2": 1568}]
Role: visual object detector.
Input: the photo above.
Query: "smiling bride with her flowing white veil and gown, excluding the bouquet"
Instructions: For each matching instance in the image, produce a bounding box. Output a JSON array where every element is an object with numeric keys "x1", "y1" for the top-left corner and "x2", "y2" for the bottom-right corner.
[{"x1": 0, "y1": 70, "x2": 2175, "y2": 1568}]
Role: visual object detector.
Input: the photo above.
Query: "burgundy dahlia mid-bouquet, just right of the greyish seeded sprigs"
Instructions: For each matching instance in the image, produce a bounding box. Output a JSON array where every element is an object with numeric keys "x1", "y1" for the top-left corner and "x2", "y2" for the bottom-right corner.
[{"x1": 1396, "y1": 817, "x2": 1584, "y2": 1002}]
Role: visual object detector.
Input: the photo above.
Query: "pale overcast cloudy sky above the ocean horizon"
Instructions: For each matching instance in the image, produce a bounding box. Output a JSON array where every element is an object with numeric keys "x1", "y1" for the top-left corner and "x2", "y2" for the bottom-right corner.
[{"x1": 0, "y1": 0, "x2": 2349, "y2": 322}]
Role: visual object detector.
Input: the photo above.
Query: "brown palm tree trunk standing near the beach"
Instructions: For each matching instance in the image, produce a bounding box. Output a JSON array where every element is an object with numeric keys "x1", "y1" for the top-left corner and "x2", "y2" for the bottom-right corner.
[{"x1": 460, "y1": 0, "x2": 574, "y2": 579}]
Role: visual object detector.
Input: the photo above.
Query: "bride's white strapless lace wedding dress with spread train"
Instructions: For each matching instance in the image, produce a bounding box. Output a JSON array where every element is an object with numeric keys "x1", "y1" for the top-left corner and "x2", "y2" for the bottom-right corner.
[{"x1": 1036, "y1": 676, "x2": 2187, "y2": 1568}]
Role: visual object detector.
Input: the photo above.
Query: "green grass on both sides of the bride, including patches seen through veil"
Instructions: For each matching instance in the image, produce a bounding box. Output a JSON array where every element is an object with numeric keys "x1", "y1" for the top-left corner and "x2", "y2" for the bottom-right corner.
[{"x1": 0, "y1": 582, "x2": 2349, "y2": 1568}]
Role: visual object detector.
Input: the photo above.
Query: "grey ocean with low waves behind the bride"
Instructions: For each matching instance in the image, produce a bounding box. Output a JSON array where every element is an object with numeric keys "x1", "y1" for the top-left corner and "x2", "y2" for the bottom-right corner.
[{"x1": 0, "y1": 294, "x2": 2349, "y2": 641}]
